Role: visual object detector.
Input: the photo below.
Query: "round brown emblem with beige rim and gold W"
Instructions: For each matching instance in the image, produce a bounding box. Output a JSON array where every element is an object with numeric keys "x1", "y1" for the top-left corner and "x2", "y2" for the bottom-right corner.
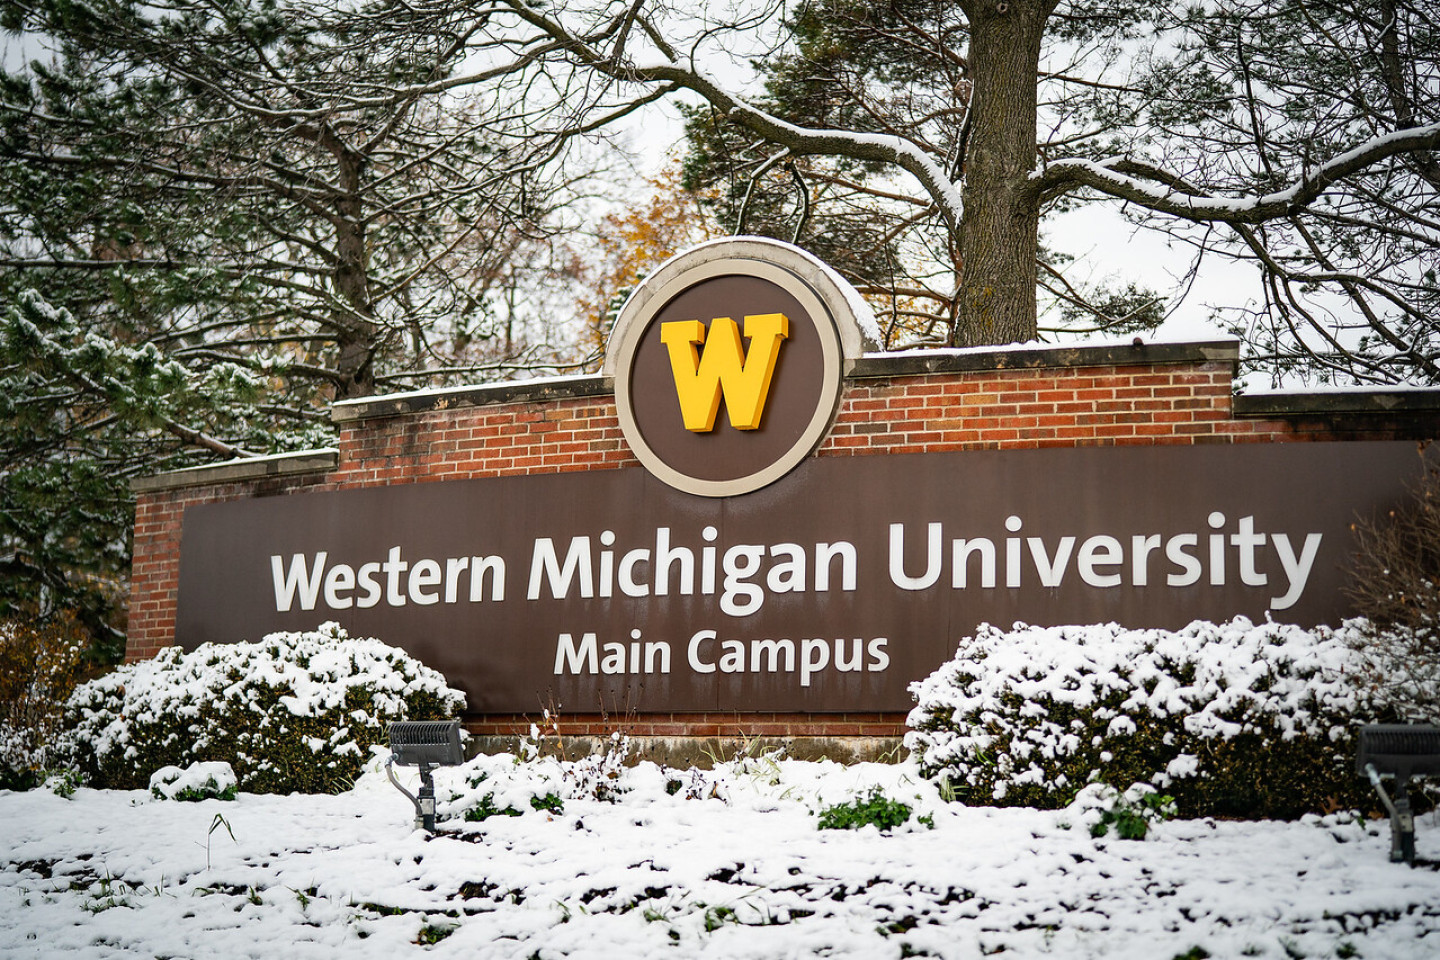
[{"x1": 605, "y1": 239, "x2": 864, "y2": 497}]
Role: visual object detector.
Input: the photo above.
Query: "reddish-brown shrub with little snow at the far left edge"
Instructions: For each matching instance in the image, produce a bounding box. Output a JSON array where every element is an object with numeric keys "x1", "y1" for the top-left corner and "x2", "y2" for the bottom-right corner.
[{"x1": 0, "y1": 615, "x2": 85, "y2": 790}]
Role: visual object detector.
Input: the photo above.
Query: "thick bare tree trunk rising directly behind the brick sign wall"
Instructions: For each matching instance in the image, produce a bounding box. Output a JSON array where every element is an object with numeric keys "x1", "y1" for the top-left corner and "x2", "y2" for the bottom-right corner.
[{"x1": 952, "y1": 0, "x2": 1054, "y2": 347}]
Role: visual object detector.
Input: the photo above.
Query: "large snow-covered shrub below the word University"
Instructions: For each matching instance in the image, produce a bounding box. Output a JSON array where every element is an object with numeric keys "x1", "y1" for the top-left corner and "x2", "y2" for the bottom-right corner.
[{"x1": 906, "y1": 617, "x2": 1374, "y2": 818}]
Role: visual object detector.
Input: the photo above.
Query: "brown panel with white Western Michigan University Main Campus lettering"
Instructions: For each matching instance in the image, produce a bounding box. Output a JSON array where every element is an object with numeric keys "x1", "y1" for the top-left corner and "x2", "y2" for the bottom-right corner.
[{"x1": 176, "y1": 443, "x2": 1421, "y2": 712}]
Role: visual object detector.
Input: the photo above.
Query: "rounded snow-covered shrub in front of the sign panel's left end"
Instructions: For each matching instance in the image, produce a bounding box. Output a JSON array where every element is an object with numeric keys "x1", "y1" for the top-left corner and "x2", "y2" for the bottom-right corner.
[{"x1": 66, "y1": 623, "x2": 465, "y2": 793}]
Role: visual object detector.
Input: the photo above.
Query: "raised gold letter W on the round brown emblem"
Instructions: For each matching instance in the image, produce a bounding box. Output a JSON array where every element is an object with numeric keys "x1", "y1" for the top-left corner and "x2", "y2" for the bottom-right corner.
[{"x1": 660, "y1": 314, "x2": 791, "y2": 433}]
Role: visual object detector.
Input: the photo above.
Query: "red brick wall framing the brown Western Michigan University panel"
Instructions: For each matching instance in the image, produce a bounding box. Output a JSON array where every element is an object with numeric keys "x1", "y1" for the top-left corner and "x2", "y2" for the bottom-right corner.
[{"x1": 125, "y1": 341, "x2": 1440, "y2": 756}]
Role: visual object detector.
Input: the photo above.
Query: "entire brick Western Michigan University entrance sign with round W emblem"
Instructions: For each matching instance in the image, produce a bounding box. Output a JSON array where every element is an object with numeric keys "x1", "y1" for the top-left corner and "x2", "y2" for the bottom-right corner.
[{"x1": 140, "y1": 239, "x2": 1440, "y2": 728}]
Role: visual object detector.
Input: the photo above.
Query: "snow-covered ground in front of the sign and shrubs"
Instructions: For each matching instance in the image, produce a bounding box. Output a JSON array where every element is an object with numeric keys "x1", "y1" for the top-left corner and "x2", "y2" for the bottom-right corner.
[{"x1": 0, "y1": 757, "x2": 1440, "y2": 960}]
